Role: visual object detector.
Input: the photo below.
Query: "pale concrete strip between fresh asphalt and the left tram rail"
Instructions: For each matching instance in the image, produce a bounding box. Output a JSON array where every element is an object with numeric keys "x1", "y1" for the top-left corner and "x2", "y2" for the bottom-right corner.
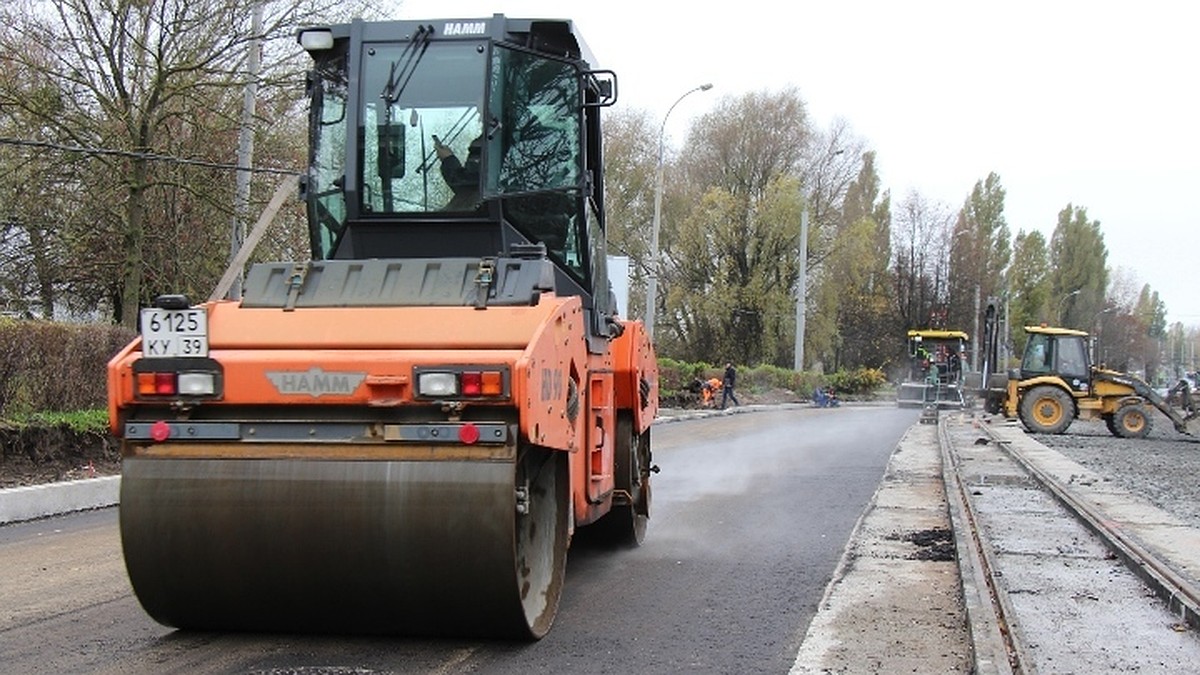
[{"x1": 791, "y1": 424, "x2": 972, "y2": 675}]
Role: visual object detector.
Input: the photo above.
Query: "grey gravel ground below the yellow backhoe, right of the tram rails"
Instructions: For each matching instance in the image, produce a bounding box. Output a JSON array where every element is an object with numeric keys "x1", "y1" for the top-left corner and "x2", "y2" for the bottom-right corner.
[{"x1": 1032, "y1": 413, "x2": 1200, "y2": 527}]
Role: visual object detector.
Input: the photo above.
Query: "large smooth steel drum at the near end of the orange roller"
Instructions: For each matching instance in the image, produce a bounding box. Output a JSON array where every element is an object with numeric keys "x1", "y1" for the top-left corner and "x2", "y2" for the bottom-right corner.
[{"x1": 120, "y1": 453, "x2": 568, "y2": 638}]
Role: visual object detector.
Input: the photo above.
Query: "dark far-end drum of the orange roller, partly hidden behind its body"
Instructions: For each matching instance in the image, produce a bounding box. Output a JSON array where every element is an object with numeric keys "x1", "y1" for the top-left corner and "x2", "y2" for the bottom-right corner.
[{"x1": 589, "y1": 413, "x2": 650, "y2": 548}]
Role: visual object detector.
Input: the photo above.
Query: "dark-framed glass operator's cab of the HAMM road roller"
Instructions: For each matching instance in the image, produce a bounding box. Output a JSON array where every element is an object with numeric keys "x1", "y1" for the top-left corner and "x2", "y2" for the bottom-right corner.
[{"x1": 299, "y1": 14, "x2": 616, "y2": 345}]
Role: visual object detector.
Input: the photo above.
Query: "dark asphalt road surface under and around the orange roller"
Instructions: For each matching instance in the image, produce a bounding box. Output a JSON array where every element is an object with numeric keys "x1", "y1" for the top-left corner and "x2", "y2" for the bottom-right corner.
[{"x1": 0, "y1": 406, "x2": 917, "y2": 674}]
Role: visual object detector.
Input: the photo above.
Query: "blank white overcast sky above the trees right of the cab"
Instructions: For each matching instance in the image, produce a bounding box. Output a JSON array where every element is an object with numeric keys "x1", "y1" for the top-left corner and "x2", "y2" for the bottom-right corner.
[{"x1": 397, "y1": 0, "x2": 1200, "y2": 328}]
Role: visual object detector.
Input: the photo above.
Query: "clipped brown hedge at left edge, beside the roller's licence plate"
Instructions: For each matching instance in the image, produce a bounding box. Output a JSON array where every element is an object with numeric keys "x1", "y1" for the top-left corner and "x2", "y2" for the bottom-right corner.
[{"x1": 0, "y1": 319, "x2": 134, "y2": 418}]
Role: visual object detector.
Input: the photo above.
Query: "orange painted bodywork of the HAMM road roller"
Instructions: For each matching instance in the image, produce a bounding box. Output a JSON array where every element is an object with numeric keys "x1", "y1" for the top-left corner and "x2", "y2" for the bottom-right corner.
[{"x1": 108, "y1": 293, "x2": 658, "y2": 525}]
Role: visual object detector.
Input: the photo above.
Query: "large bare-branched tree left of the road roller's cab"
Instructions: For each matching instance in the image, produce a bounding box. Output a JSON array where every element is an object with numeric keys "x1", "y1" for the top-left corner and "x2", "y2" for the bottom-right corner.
[{"x1": 0, "y1": 0, "x2": 343, "y2": 327}]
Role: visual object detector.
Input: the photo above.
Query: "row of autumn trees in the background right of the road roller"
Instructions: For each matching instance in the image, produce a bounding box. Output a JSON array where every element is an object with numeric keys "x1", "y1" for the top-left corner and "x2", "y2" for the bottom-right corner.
[{"x1": 606, "y1": 89, "x2": 1198, "y2": 380}]
